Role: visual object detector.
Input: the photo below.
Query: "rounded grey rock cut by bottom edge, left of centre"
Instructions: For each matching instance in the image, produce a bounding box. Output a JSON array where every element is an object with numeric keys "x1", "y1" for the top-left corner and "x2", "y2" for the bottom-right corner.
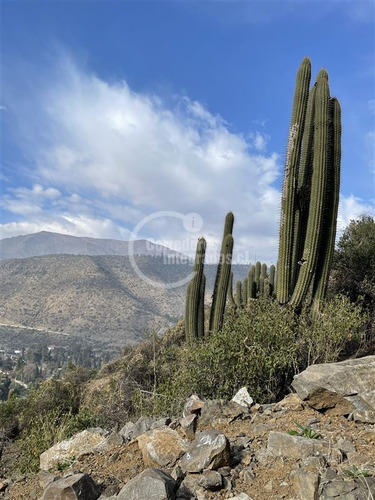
[{"x1": 116, "y1": 469, "x2": 177, "y2": 500}]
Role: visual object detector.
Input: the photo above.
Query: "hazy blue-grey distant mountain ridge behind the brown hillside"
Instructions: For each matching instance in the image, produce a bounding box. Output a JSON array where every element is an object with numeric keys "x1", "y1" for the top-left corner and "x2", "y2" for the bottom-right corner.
[{"x1": 0, "y1": 231, "x2": 187, "y2": 259}]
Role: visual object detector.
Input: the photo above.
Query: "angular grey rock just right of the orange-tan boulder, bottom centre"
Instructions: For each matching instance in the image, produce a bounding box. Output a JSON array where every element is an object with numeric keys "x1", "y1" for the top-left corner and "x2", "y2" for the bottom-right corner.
[{"x1": 180, "y1": 430, "x2": 230, "y2": 472}]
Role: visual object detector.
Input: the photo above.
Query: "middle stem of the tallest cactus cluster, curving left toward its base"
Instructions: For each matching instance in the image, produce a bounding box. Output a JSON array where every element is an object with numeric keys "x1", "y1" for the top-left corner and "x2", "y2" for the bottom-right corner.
[{"x1": 290, "y1": 70, "x2": 330, "y2": 310}]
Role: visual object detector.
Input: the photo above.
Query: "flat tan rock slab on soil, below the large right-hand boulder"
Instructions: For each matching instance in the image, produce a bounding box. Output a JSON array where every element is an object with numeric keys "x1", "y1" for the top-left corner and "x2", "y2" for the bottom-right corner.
[{"x1": 267, "y1": 431, "x2": 329, "y2": 459}]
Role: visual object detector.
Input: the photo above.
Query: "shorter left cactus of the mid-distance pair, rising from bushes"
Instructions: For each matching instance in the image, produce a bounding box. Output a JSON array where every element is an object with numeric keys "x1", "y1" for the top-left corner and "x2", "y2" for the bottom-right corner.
[{"x1": 185, "y1": 238, "x2": 206, "y2": 342}]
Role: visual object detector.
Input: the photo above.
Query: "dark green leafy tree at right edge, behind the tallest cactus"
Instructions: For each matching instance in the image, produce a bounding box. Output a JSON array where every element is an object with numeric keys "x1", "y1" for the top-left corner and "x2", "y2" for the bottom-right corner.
[{"x1": 331, "y1": 214, "x2": 375, "y2": 307}]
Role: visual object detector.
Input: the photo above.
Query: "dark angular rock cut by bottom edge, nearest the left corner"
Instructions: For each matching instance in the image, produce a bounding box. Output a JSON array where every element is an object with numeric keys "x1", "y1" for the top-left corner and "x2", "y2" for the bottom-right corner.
[{"x1": 41, "y1": 474, "x2": 100, "y2": 500}]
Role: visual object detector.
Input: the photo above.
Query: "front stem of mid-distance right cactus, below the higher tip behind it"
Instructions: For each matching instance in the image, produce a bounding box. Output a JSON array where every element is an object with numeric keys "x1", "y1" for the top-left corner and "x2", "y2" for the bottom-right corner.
[{"x1": 211, "y1": 234, "x2": 233, "y2": 332}]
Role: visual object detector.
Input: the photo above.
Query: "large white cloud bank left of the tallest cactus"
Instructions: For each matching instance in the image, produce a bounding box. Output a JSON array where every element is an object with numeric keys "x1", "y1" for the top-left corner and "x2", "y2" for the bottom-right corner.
[{"x1": 5, "y1": 56, "x2": 281, "y2": 260}]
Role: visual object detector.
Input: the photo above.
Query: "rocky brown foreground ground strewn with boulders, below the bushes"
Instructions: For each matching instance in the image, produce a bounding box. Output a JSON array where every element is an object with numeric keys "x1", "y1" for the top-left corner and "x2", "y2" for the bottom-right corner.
[{"x1": 0, "y1": 356, "x2": 375, "y2": 500}]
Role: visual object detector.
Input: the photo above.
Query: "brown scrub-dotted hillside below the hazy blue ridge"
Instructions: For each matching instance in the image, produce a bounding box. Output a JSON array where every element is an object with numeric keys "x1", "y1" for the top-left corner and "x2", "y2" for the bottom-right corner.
[{"x1": 0, "y1": 255, "x2": 253, "y2": 352}]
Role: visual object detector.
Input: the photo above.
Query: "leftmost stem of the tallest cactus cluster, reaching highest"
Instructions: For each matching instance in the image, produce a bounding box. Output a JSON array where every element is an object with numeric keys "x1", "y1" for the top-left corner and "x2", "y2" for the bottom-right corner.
[{"x1": 277, "y1": 58, "x2": 311, "y2": 304}]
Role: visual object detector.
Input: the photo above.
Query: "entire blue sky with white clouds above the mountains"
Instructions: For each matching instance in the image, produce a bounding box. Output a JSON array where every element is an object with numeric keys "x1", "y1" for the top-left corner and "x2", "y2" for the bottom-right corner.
[{"x1": 0, "y1": 0, "x2": 375, "y2": 262}]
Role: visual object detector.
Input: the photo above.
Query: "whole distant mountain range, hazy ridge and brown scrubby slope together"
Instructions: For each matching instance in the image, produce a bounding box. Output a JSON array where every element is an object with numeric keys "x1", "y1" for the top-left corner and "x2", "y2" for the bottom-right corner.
[{"x1": 0, "y1": 231, "x2": 249, "y2": 351}]
